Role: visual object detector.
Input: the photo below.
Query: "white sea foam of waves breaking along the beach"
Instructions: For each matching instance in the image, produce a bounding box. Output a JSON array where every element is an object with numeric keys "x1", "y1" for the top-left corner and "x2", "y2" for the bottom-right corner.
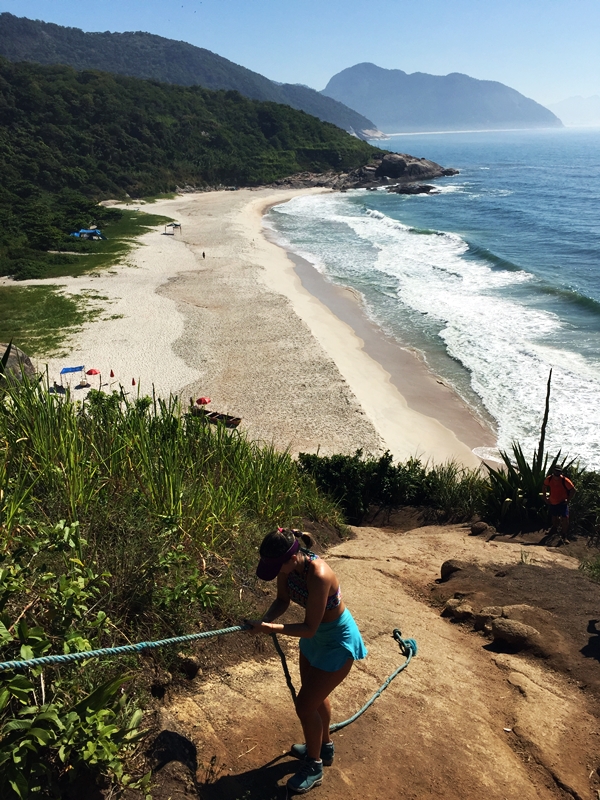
[{"x1": 270, "y1": 193, "x2": 600, "y2": 468}]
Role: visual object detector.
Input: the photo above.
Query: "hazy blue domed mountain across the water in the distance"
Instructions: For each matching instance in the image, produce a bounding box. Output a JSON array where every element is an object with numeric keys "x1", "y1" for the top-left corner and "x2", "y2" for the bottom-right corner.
[{"x1": 322, "y1": 62, "x2": 562, "y2": 133}]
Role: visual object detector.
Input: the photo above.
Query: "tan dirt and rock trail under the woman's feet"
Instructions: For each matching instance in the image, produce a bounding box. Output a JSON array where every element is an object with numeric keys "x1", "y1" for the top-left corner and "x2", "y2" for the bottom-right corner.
[{"x1": 157, "y1": 526, "x2": 600, "y2": 800}]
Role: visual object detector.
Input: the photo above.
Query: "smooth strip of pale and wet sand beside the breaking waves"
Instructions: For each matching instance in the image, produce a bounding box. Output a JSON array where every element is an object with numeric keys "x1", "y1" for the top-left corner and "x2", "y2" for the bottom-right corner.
[{"x1": 246, "y1": 195, "x2": 496, "y2": 466}]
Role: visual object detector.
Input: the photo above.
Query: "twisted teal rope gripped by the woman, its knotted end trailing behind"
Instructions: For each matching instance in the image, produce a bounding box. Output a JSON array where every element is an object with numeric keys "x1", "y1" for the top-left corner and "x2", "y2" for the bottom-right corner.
[{"x1": 0, "y1": 625, "x2": 417, "y2": 733}]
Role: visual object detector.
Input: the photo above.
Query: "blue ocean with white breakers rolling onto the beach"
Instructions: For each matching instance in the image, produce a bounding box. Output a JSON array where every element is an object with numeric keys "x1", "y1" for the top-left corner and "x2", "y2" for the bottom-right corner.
[{"x1": 265, "y1": 129, "x2": 600, "y2": 469}]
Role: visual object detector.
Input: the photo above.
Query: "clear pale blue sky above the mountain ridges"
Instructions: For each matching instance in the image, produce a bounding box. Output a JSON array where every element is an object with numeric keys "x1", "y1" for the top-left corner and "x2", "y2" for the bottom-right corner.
[{"x1": 0, "y1": 0, "x2": 600, "y2": 105}]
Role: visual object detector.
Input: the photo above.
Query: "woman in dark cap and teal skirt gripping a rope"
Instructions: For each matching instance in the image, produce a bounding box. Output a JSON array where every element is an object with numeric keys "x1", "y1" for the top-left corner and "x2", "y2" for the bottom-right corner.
[{"x1": 247, "y1": 528, "x2": 367, "y2": 794}]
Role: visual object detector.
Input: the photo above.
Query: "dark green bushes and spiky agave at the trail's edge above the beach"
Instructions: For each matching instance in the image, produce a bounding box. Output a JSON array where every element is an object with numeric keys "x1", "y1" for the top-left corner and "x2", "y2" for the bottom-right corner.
[{"x1": 298, "y1": 444, "x2": 600, "y2": 544}]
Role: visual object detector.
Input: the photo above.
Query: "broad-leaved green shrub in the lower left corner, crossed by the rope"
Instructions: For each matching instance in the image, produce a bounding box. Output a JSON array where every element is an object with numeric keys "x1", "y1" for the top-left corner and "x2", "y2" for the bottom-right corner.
[{"x1": 0, "y1": 522, "x2": 147, "y2": 799}]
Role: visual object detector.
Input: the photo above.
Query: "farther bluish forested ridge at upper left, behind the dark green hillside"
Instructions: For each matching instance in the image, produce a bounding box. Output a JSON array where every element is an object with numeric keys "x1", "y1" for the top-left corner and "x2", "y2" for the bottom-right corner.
[{"x1": 0, "y1": 13, "x2": 375, "y2": 136}]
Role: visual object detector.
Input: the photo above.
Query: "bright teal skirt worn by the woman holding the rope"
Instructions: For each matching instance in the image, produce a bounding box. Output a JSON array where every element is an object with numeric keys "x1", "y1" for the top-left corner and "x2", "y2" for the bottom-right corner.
[{"x1": 300, "y1": 609, "x2": 367, "y2": 672}]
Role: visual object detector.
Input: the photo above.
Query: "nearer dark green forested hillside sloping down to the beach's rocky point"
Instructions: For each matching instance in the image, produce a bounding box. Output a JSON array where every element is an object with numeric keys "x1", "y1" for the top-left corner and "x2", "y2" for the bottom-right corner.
[{"x1": 0, "y1": 58, "x2": 377, "y2": 277}]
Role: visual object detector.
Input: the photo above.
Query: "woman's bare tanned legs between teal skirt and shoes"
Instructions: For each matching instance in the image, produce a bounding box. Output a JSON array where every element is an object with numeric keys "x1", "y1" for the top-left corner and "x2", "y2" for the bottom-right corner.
[{"x1": 296, "y1": 654, "x2": 354, "y2": 759}]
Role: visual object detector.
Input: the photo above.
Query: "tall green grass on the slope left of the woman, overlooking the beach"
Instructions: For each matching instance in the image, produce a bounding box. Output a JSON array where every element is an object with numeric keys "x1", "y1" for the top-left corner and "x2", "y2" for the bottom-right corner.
[{"x1": 0, "y1": 380, "x2": 342, "y2": 633}]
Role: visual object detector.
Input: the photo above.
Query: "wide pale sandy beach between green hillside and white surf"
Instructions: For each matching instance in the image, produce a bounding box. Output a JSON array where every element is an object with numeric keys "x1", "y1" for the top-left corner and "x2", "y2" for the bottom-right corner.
[{"x1": 32, "y1": 189, "x2": 495, "y2": 466}]
